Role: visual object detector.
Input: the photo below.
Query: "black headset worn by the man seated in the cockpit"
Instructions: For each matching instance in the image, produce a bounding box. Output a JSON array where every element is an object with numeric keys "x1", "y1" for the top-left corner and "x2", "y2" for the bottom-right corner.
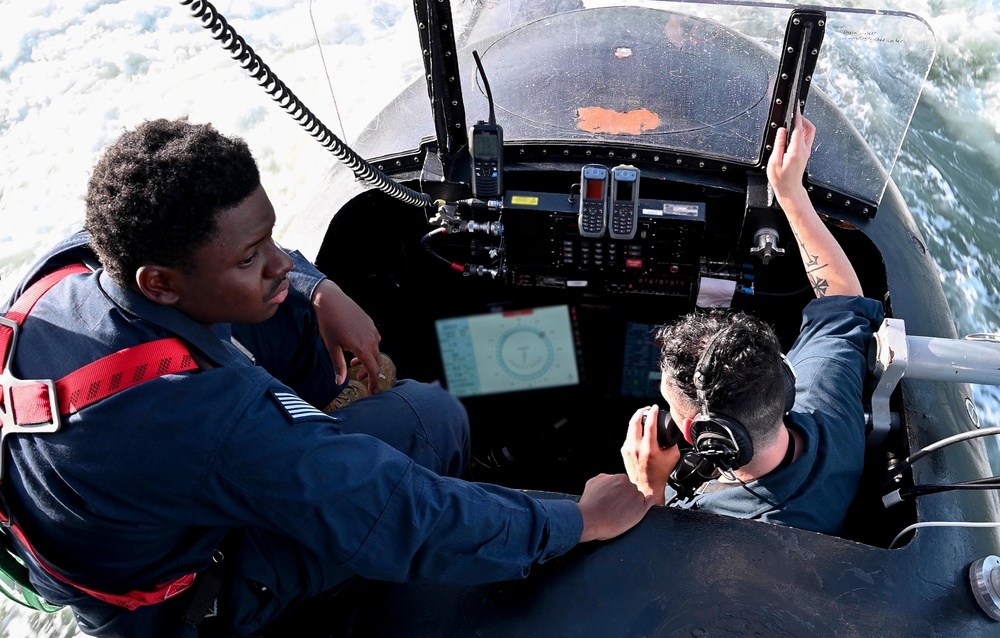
[{"x1": 668, "y1": 328, "x2": 795, "y2": 499}]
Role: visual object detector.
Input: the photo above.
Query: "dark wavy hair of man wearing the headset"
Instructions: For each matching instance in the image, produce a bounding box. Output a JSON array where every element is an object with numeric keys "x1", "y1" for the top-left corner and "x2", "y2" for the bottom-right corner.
[{"x1": 656, "y1": 310, "x2": 785, "y2": 446}]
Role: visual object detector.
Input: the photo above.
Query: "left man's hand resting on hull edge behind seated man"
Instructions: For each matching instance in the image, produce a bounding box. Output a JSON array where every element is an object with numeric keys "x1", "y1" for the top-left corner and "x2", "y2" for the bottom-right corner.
[{"x1": 579, "y1": 474, "x2": 653, "y2": 543}]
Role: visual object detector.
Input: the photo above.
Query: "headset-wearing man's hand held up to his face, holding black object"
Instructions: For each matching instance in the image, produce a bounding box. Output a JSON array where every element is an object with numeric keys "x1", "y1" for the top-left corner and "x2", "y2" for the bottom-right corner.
[{"x1": 622, "y1": 405, "x2": 681, "y2": 505}]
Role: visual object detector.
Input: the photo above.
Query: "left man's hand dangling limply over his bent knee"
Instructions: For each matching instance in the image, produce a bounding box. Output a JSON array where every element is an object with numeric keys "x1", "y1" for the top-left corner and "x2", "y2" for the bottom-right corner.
[{"x1": 312, "y1": 279, "x2": 382, "y2": 393}]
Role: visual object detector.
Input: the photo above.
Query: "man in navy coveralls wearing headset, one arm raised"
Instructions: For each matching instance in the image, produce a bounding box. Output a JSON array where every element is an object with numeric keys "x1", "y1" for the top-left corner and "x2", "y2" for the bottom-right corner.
[{"x1": 622, "y1": 114, "x2": 883, "y2": 534}]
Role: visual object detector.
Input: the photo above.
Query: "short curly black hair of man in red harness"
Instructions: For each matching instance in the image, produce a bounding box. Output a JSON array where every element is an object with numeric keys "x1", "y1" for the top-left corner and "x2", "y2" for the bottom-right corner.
[{"x1": 86, "y1": 118, "x2": 260, "y2": 286}]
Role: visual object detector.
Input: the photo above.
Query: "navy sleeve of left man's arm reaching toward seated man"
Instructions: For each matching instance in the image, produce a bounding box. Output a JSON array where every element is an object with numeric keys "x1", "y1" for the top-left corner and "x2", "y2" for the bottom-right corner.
[{"x1": 203, "y1": 376, "x2": 583, "y2": 584}]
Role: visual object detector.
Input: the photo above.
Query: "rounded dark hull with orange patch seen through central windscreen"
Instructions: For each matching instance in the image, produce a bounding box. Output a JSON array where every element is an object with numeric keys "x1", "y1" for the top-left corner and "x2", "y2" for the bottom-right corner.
[{"x1": 466, "y1": 7, "x2": 777, "y2": 163}]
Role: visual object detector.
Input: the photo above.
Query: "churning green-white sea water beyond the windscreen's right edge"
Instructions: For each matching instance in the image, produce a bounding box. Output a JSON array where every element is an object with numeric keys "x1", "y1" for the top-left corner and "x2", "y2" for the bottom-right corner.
[{"x1": 893, "y1": 0, "x2": 1000, "y2": 436}]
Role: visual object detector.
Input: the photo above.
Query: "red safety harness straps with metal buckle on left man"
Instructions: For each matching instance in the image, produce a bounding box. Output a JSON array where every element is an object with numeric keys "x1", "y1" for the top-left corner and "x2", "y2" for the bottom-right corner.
[{"x1": 0, "y1": 265, "x2": 198, "y2": 609}]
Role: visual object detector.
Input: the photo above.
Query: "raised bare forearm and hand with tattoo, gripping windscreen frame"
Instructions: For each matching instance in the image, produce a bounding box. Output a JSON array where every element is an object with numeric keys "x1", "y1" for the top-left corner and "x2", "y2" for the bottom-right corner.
[{"x1": 767, "y1": 115, "x2": 863, "y2": 297}]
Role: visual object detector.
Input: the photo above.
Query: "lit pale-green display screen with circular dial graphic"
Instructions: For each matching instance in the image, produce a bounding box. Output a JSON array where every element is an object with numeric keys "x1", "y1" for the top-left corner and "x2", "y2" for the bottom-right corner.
[{"x1": 435, "y1": 305, "x2": 580, "y2": 397}]
